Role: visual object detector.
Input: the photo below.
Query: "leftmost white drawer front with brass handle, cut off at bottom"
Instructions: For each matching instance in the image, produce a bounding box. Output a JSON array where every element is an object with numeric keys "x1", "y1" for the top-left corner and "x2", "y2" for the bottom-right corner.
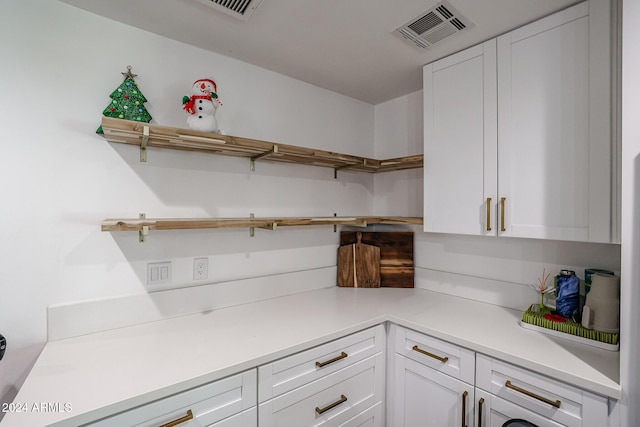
[{"x1": 91, "y1": 369, "x2": 257, "y2": 427}]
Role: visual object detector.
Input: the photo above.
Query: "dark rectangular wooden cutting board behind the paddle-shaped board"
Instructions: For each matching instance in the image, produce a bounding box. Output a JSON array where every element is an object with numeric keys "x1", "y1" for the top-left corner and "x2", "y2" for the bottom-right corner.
[{"x1": 340, "y1": 231, "x2": 414, "y2": 288}]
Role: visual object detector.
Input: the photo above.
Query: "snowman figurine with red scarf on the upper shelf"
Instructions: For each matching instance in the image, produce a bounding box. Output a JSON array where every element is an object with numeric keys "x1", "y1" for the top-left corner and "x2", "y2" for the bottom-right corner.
[{"x1": 182, "y1": 79, "x2": 222, "y2": 133}]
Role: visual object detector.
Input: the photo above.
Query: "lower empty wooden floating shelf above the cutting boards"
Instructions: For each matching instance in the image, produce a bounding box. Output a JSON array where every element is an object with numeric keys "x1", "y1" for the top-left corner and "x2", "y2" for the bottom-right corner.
[{"x1": 102, "y1": 216, "x2": 422, "y2": 232}]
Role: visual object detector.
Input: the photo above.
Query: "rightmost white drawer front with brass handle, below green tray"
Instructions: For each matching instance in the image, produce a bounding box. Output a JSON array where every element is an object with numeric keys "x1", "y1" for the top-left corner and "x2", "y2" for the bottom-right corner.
[{"x1": 476, "y1": 355, "x2": 608, "y2": 427}]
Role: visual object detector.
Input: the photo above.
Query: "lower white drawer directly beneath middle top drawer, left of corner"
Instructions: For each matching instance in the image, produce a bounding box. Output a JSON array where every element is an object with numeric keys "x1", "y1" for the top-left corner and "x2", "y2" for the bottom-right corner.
[{"x1": 258, "y1": 352, "x2": 384, "y2": 427}]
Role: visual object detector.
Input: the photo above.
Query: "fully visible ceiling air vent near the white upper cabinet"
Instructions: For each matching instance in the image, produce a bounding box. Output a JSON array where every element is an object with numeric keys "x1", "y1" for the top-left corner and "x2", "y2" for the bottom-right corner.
[{"x1": 394, "y1": 1, "x2": 473, "y2": 50}]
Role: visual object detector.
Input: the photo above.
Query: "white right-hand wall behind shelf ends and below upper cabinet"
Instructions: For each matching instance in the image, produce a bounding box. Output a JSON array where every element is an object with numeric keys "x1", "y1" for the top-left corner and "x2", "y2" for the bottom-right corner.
[{"x1": 374, "y1": 91, "x2": 620, "y2": 309}]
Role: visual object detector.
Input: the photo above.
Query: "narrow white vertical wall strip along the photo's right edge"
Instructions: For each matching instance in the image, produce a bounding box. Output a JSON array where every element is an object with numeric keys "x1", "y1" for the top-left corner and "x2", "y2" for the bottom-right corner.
[{"x1": 620, "y1": 0, "x2": 640, "y2": 426}]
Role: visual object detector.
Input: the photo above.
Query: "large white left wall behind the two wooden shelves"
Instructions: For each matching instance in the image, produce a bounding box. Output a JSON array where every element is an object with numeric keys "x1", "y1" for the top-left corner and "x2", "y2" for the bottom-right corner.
[{"x1": 0, "y1": 0, "x2": 374, "y2": 408}]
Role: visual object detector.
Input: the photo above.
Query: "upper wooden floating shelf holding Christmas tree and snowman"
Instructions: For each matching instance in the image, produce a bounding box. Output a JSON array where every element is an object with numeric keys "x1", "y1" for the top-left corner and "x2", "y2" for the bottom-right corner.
[{"x1": 102, "y1": 116, "x2": 424, "y2": 173}]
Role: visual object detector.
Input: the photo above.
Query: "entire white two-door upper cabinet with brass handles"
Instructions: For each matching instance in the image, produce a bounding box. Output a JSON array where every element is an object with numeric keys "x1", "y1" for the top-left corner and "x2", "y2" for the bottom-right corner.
[{"x1": 424, "y1": 1, "x2": 618, "y2": 242}]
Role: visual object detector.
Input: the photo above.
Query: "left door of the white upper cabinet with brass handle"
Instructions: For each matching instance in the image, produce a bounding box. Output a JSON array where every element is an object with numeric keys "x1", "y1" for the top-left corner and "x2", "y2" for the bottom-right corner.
[{"x1": 423, "y1": 40, "x2": 497, "y2": 236}]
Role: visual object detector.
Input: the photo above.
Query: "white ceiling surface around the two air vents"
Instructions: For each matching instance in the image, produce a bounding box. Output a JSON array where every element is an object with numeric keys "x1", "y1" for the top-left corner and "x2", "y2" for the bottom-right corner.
[{"x1": 61, "y1": 0, "x2": 577, "y2": 105}]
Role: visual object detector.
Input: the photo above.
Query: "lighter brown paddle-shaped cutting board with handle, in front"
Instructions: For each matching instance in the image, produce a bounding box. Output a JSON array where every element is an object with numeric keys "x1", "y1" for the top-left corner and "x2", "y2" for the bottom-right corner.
[{"x1": 338, "y1": 233, "x2": 380, "y2": 288}]
